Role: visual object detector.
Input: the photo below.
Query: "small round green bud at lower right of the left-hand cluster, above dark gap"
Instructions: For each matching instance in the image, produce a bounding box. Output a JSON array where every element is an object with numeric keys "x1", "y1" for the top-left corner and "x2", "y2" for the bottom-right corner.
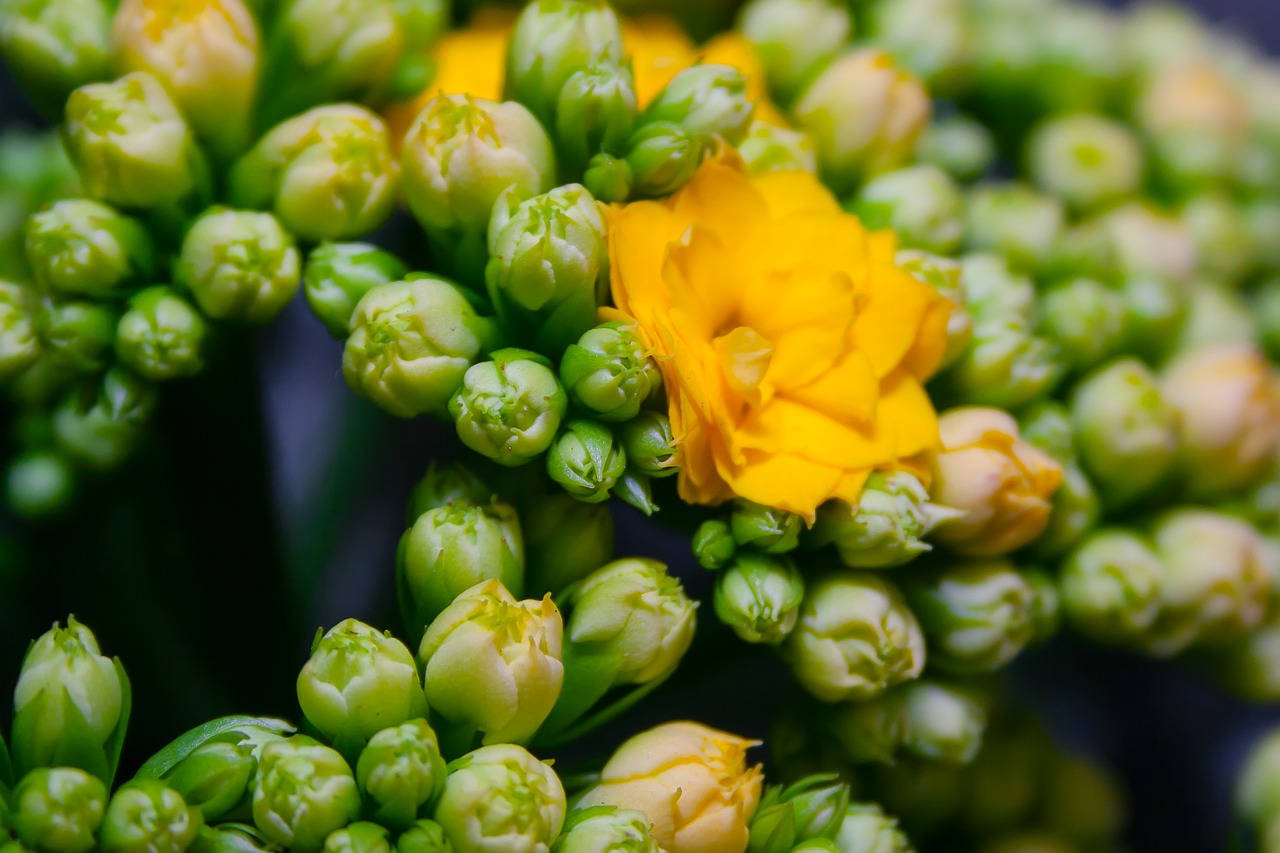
[{"x1": 115, "y1": 286, "x2": 205, "y2": 382}]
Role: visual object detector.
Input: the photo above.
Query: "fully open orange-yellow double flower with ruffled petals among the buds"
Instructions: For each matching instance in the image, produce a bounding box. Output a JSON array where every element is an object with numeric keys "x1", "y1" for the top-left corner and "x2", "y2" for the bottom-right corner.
[{"x1": 609, "y1": 158, "x2": 950, "y2": 520}]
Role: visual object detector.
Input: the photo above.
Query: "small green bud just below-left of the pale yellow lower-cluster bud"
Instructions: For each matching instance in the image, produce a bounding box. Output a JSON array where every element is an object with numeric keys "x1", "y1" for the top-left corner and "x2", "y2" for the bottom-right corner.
[{"x1": 356, "y1": 720, "x2": 445, "y2": 829}]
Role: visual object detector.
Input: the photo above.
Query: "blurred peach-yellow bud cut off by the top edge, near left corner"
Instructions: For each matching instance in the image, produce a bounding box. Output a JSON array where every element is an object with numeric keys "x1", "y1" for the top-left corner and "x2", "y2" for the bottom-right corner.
[{"x1": 111, "y1": 0, "x2": 261, "y2": 158}]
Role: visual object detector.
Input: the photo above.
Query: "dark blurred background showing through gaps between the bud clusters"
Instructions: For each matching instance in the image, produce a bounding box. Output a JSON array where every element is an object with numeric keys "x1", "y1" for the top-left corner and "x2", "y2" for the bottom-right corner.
[{"x1": 0, "y1": 0, "x2": 1280, "y2": 852}]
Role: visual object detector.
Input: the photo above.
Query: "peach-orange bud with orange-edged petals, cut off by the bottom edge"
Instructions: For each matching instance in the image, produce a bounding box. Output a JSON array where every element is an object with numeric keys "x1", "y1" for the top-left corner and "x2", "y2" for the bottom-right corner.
[{"x1": 579, "y1": 722, "x2": 763, "y2": 853}]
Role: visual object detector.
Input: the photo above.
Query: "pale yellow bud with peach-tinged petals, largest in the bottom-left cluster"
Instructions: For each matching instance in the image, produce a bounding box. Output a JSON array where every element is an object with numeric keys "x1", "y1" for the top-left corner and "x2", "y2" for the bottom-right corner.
[{"x1": 417, "y1": 580, "x2": 564, "y2": 742}]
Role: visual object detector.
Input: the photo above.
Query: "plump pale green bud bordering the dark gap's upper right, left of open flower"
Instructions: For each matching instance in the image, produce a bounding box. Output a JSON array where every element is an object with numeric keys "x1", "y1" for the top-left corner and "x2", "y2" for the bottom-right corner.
[{"x1": 342, "y1": 275, "x2": 497, "y2": 418}]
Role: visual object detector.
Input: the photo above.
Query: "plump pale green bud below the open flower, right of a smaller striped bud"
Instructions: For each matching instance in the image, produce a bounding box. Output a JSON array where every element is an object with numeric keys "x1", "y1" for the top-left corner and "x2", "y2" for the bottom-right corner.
[{"x1": 786, "y1": 571, "x2": 924, "y2": 702}]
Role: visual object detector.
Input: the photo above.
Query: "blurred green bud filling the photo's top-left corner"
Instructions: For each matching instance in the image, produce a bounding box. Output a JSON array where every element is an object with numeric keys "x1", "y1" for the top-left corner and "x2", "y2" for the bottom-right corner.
[{"x1": 0, "y1": 0, "x2": 111, "y2": 114}]
